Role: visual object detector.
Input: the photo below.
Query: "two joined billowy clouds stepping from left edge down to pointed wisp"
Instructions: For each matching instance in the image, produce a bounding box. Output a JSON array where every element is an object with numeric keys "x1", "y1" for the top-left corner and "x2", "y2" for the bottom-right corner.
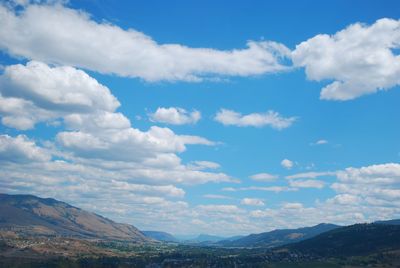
[{"x1": 0, "y1": 61, "x2": 219, "y2": 165}]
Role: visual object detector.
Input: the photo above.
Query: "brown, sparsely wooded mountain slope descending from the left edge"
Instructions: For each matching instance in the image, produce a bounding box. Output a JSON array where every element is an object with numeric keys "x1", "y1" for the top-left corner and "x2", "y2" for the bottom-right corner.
[{"x1": 0, "y1": 194, "x2": 150, "y2": 242}]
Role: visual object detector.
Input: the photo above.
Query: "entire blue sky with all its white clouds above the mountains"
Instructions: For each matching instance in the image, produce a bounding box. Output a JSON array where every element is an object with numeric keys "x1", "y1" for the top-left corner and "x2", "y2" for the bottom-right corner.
[{"x1": 0, "y1": 0, "x2": 400, "y2": 236}]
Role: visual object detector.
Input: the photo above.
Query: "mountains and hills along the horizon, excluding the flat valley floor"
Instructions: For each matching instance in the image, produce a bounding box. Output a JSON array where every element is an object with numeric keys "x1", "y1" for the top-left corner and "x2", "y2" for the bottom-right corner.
[{"x1": 0, "y1": 194, "x2": 400, "y2": 252}]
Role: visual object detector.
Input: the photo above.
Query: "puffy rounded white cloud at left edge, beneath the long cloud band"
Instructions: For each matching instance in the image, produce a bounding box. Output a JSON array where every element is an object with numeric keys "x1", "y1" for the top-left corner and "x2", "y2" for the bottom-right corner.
[{"x1": 0, "y1": 61, "x2": 120, "y2": 130}]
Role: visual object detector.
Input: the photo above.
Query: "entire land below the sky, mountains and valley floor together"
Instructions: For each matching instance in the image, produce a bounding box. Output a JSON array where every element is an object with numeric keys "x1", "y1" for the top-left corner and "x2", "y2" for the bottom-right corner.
[{"x1": 0, "y1": 194, "x2": 400, "y2": 267}]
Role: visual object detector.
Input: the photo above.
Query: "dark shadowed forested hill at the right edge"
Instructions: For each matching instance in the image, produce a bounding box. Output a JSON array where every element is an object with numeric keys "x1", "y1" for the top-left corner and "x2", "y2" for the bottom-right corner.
[{"x1": 282, "y1": 223, "x2": 400, "y2": 257}]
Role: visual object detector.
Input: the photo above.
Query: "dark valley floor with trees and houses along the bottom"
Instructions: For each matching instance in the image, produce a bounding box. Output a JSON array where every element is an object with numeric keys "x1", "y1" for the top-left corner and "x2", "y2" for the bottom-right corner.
[{"x1": 0, "y1": 237, "x2": 400, "y2": 268}]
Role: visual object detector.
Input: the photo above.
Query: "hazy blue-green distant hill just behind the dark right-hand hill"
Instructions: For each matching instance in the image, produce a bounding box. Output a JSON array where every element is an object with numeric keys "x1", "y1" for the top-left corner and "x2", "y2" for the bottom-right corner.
[{"x1": 217, "y1": 223, "x2": 339, "y2": 248}]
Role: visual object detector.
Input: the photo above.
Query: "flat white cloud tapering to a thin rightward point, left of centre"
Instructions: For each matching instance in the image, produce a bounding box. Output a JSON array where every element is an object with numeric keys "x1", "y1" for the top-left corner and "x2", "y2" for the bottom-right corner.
[{"x1": 57, "y1": 126, "x2": 213, "y2": 161}]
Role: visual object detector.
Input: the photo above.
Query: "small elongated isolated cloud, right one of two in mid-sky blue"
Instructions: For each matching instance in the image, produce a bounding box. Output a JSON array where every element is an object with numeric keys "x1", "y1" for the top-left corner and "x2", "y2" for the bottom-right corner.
[{"x1": 214, "y1": 109, "x2": 296, "y2": 130}]
